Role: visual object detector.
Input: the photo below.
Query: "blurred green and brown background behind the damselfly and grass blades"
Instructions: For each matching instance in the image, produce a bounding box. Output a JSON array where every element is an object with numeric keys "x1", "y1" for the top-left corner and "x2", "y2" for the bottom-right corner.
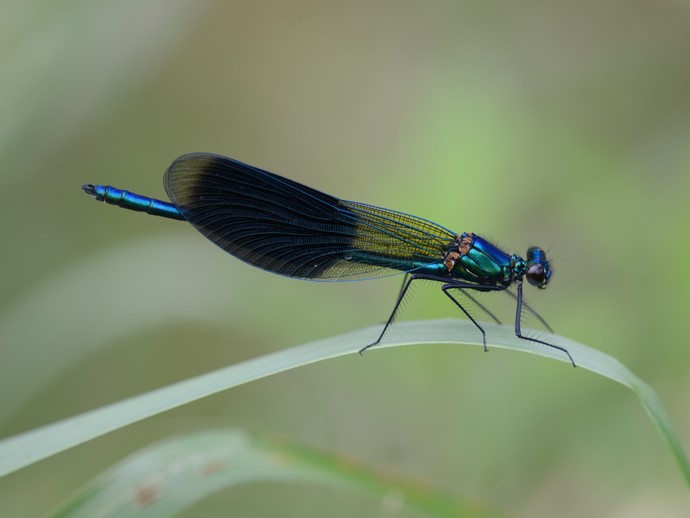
[{"x1": 0, "y1": 0, "x2": 690, "y2": 517}]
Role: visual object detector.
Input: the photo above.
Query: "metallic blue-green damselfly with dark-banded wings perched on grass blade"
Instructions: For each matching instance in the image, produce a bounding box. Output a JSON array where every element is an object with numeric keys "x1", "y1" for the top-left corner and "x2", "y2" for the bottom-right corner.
[{"x1": 83, "y1": 153, "x2": 575, "y2": 366}]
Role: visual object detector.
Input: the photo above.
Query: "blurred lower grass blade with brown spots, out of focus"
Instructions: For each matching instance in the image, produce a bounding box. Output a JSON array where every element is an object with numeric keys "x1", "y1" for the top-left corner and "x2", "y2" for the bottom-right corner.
[{"x1": 50, "y1": 429, "x2": 497, "y2": 518}]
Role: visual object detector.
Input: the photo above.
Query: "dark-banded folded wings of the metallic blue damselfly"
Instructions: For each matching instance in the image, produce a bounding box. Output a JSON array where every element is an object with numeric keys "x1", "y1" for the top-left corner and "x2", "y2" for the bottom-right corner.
[{"x1": 164, "y1": 153, "x2": 455, "y2": 280}]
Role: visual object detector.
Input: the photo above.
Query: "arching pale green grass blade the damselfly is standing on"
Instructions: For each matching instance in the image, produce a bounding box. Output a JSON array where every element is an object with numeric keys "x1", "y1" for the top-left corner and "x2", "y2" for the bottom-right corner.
[{"x1": 0, "y1": 320, "x2": 690, "y2": 487}]
